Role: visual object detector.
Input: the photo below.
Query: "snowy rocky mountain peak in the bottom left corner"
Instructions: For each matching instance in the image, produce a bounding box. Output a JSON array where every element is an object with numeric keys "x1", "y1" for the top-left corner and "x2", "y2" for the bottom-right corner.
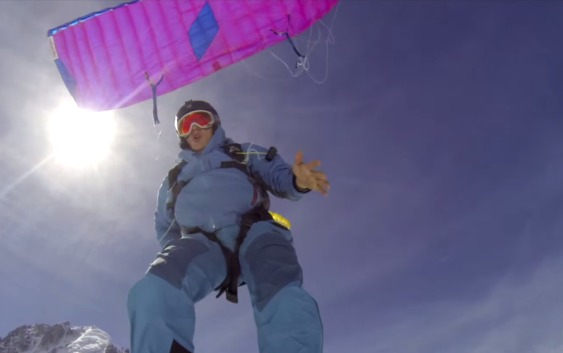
[{"x1": 0, "y1": 322, "x2": 129, "y2": 353}]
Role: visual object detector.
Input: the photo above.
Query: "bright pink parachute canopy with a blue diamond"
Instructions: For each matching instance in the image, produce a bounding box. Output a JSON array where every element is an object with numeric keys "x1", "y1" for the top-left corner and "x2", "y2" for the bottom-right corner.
[{"x1": 48, "y1": 0, "x2": 338, "y2": 111}]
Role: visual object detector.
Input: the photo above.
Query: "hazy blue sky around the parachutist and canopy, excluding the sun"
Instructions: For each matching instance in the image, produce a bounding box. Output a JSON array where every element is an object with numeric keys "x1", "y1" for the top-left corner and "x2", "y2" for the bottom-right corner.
[{"x1": 0, "y1": 1, "x2": 563, "y2": 353}]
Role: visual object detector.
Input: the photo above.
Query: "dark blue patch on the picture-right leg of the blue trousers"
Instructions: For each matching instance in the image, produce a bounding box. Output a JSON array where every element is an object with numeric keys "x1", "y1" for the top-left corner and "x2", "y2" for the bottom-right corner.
[{"x1": 245, "y1": 233, "x2": 303, "y2": 311}]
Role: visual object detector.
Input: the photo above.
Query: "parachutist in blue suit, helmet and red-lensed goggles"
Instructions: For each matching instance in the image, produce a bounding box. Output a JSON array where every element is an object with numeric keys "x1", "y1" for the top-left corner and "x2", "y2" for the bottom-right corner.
[{"x1": 127, "y1": 101, "x2": 330, "y2": 353}]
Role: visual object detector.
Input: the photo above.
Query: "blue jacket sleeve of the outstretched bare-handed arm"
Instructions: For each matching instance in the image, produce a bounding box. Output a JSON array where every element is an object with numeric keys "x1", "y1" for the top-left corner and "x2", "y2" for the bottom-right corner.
[{"x1": 241, "y1": 143, "x2": 311, "y2": 201}]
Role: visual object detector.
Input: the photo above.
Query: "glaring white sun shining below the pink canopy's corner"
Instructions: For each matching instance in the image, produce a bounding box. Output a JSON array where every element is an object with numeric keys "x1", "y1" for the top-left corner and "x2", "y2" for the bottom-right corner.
[{"x1": 49, "y1": 103, "x2": 115, "y2": 168}]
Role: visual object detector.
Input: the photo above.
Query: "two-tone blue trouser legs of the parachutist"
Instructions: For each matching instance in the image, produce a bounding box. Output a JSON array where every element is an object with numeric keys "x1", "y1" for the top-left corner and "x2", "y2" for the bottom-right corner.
[{"x1": 128, "y1": 222, "x2": 323, "y2": 353}]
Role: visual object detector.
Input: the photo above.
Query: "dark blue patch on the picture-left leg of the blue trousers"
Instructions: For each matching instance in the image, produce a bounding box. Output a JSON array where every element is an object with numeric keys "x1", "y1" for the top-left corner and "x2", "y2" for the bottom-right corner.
[{"x1": 147, "y1": 238, "x2": 209, "y2": 289}]
